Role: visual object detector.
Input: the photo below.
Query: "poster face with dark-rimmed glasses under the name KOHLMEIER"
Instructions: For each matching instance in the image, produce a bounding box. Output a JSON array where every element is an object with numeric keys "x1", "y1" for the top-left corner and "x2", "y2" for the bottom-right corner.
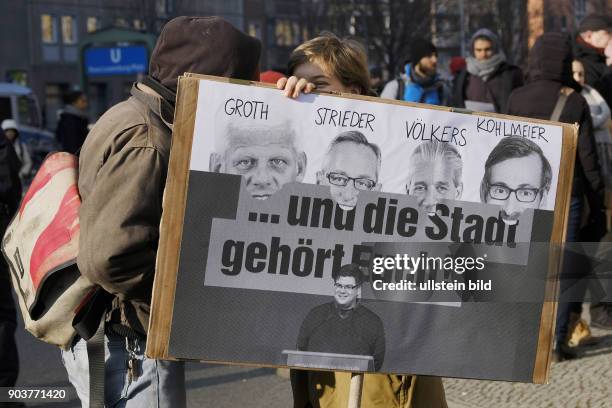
[{"x1": 480, "y1": 136, "x2": 552, "y2": 225}]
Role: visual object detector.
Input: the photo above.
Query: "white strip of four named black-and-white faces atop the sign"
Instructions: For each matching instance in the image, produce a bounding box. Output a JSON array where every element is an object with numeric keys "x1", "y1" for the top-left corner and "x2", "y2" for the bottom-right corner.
[{"x1": 190, "y1": 82, "x2": 561, "y2": 223}]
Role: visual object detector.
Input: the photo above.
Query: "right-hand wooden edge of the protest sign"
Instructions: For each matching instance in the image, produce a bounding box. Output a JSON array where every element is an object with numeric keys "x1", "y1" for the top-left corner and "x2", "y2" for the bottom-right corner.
[{"x1": 532, "y1": 123, "x2": 578, "y2": 384}]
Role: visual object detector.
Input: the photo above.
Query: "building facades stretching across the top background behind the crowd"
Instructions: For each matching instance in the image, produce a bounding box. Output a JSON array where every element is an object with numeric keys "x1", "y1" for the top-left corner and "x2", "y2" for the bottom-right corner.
[{"x1": 0, "y1": 0, "x2": 612, "y2": 129}]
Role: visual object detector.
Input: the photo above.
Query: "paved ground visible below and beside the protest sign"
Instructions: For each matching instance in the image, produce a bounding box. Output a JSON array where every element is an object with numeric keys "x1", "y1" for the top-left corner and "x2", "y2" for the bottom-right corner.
[{"x1": 17, "y1": 294, "x2": 612, "y2": 408}]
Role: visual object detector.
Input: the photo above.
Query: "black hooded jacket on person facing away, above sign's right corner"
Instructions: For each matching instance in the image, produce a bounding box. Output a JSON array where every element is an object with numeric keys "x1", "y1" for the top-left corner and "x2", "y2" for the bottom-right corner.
[{"x1": 507, "y1": 33, "x2": 604, "y2": 212}]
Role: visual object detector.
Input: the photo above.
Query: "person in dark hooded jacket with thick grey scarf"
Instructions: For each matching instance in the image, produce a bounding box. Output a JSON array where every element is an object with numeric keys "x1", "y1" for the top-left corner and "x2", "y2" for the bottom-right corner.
[{"x1": 451, "y1": 28, "x2": 523, "y2": 112}]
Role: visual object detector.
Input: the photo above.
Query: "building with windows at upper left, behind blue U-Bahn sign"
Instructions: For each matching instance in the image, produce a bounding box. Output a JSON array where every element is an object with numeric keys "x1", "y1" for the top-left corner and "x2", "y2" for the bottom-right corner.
[{"x1": 0, "y1": 0, "x2": 244, "y2": 130}]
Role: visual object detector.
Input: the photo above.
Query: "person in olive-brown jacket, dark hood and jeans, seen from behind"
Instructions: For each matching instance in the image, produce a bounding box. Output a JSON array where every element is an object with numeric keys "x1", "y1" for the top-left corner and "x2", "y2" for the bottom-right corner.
[{"x1": 62, "y1": 17, "x2": 261, "y2": 408}]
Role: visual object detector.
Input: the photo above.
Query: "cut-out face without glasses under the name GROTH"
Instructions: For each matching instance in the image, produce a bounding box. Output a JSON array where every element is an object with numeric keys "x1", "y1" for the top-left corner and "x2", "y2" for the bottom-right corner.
[{"x1": 209, "y1": 123, "x2": 306, "y2": 200}]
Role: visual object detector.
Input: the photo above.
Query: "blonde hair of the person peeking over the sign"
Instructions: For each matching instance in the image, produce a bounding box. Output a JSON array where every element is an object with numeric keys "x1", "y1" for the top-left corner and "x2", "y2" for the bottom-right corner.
[{"x1": 287, "y1": 33, "x2": 376, "y2": 96}]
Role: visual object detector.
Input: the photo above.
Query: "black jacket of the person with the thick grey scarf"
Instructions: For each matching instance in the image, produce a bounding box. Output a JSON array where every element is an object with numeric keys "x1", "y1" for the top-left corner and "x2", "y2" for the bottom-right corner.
[{"x1": 451, "y1": 62, "x2": 523, "y2": 112}]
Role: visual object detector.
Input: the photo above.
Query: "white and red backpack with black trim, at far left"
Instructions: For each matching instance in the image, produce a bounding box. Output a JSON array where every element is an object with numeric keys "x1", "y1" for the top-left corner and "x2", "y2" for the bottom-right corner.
[{"x1": 0, "y1": 152, "x2": 99, "y2": 349}]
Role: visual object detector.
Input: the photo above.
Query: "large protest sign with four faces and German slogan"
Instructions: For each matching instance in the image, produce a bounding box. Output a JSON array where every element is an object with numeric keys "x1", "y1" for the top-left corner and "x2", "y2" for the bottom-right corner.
[{"x1": 147, "y1": 75, "x2": 576, "y2": 383}]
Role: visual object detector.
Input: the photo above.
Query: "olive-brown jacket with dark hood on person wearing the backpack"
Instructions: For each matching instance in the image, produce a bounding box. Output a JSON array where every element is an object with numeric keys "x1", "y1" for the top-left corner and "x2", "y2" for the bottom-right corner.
[{"x1": 77, "y1": 17, "x2": 260, "y2": 334}]
